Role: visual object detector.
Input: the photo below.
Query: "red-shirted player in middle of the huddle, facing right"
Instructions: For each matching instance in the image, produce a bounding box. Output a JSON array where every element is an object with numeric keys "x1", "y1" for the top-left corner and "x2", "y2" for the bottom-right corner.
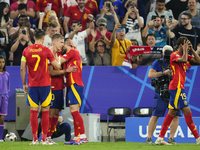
[{"x1": 47, "y1": 33, "x2": 77, "y2": 145}]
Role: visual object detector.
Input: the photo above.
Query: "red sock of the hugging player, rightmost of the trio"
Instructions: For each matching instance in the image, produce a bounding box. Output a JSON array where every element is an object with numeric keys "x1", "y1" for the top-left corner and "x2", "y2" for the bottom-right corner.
[{"x1": 72, "y1": 111, "x2": 85, "y2": 134}]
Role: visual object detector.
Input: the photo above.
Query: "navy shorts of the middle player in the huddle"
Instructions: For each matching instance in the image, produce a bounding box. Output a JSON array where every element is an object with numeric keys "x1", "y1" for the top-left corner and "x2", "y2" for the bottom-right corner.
[{"x1": 50, "y1": 90, "x2": 64, "y2": 109}]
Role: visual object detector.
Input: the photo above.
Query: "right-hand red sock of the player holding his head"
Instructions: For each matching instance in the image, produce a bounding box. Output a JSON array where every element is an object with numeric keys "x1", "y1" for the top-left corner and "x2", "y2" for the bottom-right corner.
[{"x1": 184, "y1": 113, "x2": 199, "y2": 139}]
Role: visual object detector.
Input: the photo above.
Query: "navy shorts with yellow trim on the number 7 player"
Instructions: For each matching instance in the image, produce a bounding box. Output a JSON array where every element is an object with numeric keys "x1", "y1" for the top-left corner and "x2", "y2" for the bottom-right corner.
[{"x1": 26, "y1": 86, "x2": 51, "y2": 107}]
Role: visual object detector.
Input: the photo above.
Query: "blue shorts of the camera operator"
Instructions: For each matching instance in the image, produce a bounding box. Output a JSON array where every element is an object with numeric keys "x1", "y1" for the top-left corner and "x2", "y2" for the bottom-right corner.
[{"x1": 152, "y1": 93, "x2": 181, "y2": 117}]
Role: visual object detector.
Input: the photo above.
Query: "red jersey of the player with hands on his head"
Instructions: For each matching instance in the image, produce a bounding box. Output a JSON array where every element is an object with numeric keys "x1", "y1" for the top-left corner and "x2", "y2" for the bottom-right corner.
[{"x1": 169, "y1": 51, "x2": 192, "y2": 90}]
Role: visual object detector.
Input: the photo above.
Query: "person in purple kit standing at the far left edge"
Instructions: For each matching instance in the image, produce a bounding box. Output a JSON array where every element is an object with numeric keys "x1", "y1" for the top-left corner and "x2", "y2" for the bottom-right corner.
[{"x1": 0, "y1": 55, "x2": 10, "y2": 142}]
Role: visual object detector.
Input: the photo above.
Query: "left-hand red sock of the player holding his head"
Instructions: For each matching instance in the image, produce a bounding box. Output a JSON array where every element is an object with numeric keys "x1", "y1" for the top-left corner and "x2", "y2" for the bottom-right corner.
[{"x1": 159, "y1": 114, "x2": 174, "y2": 138}]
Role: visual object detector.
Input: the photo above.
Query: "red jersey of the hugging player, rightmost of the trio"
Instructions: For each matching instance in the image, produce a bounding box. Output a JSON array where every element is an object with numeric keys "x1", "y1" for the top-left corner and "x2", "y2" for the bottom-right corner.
[{"x1": 63, "y1": 49, "x2": 83, "y2": 87}]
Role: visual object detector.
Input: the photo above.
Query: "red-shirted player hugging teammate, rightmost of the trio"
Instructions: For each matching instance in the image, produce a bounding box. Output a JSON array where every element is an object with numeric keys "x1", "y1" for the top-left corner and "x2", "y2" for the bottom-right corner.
[{"x1": 60, "y1": 38, "x2": 88, "y2": 145}]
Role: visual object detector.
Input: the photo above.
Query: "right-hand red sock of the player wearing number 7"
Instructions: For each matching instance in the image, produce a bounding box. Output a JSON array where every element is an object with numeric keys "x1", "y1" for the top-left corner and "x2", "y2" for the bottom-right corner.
[{"x1": 41, "y1": 111, "x2": 49, "y2": 141}]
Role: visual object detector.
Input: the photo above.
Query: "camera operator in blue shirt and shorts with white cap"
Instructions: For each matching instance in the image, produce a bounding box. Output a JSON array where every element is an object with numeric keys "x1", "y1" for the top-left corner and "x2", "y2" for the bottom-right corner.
[{"x1": 146, "y1": 45, "x2": 181, "y2": 144}]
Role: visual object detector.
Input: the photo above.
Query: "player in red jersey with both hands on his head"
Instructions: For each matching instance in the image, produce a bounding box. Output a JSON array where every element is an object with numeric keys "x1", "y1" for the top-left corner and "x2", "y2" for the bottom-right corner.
[{"x1": 155, "y1": 37, "x2": 200, "y2": 145}]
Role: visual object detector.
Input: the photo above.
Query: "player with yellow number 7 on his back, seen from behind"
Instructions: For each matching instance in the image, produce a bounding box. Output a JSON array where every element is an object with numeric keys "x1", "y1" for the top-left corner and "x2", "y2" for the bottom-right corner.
[{"x1": 21, "y1": 29, "x2": 60, "y2": 145}]
